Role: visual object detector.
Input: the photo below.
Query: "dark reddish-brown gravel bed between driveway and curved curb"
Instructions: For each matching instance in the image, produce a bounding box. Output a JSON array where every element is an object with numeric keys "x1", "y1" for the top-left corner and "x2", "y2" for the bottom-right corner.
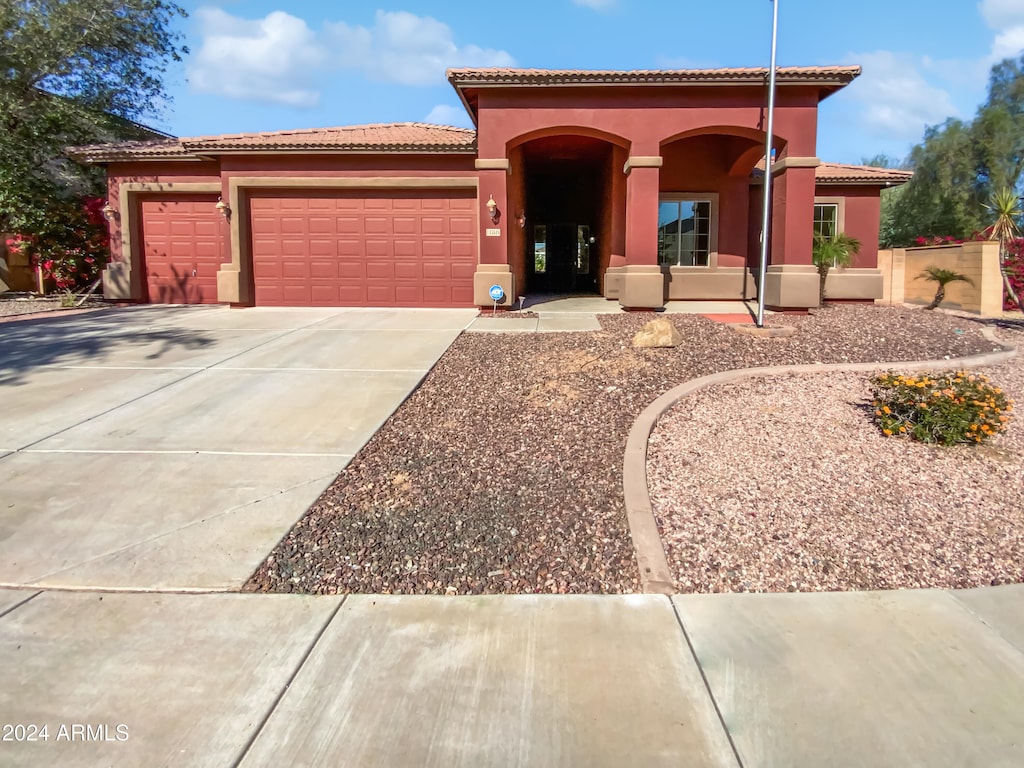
[{"x1": 246, "y1": 305, "x2": 1011, "y2": 594}]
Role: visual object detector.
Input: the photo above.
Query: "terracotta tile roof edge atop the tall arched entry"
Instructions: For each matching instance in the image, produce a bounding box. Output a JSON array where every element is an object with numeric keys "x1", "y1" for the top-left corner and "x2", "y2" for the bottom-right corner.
[{"x1": 447, "y1": 67, "x2": 860, "y2": 88}]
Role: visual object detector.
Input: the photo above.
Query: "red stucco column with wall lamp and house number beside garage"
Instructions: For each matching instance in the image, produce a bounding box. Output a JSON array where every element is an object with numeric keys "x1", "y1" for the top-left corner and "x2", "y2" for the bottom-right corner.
[{"x1": 473, "y1": 158, "x2": 516, "y2": 306}]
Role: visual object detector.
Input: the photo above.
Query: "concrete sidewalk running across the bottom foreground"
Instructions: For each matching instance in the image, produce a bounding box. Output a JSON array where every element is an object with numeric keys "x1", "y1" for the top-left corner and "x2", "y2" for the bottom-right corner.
[{"x1": 0, "y1": 585, "x2": 1024, "y2": 767}]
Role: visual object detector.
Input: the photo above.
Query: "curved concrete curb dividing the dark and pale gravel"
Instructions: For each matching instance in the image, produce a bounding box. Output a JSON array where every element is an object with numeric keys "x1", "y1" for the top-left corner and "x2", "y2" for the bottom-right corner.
[{"x1": 623, "y1": 328, "x2": 1017, "y2": 595}]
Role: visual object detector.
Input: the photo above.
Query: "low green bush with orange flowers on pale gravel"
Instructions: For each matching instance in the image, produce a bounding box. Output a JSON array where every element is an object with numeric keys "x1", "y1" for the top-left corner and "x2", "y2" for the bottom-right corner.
[{"x1": 871, "y1": 371, "x2": 1014, "y2": 445}]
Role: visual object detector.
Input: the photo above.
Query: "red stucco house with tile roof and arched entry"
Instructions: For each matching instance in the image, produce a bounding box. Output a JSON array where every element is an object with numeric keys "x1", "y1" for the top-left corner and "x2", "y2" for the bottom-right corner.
[{"x1": 68, "y1": 67, "x2": 909, "y2": 309}]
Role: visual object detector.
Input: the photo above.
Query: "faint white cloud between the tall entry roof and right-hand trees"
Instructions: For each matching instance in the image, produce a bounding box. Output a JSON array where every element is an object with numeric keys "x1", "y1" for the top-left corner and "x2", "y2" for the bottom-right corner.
[{"x1": 849, "y1": 50, "x2": 957, "y2": 140}]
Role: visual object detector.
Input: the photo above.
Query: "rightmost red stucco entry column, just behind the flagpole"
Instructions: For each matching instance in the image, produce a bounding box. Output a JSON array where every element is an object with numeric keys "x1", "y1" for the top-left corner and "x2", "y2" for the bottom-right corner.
[{"x1": 765, "y1": 158, "x2": 820, "y2": 309}]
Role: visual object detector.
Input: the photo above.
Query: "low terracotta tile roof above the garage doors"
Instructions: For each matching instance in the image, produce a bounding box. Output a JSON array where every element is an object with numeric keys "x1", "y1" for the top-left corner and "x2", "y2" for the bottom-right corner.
[{"x1": 69, "y1": 123, "x2": 476, "y2": 163}]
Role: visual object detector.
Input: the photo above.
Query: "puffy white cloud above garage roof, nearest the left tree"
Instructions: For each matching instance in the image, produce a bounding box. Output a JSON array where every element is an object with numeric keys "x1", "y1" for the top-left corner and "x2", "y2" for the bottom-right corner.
[{"x1": 188, "y1": 8, "x2": 328, "y2": 106}]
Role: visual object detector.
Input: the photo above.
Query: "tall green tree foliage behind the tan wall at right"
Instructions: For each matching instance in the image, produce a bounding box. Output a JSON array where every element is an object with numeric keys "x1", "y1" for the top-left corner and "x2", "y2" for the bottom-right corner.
[{"x1": 880, "y1": 56, "x2": 1024, "y2": 247}]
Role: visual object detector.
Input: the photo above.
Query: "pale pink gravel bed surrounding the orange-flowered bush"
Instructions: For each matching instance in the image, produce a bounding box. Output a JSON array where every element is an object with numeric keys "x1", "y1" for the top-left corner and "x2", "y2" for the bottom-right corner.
[{"x1": 647, "y1": 321, "x2": 1024, "y2": 592}]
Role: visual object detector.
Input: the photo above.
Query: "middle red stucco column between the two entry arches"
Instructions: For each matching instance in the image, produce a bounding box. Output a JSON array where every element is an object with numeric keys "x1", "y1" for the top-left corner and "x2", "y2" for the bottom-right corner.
[{"x1": 618, "y1": 156, "x2": 665, "y2": 309}]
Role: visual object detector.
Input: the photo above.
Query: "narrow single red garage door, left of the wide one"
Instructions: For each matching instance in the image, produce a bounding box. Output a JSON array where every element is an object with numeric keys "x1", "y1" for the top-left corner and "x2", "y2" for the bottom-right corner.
[{"x1": 139, "y1": 195, "x2": 227, "y2": 304}]
